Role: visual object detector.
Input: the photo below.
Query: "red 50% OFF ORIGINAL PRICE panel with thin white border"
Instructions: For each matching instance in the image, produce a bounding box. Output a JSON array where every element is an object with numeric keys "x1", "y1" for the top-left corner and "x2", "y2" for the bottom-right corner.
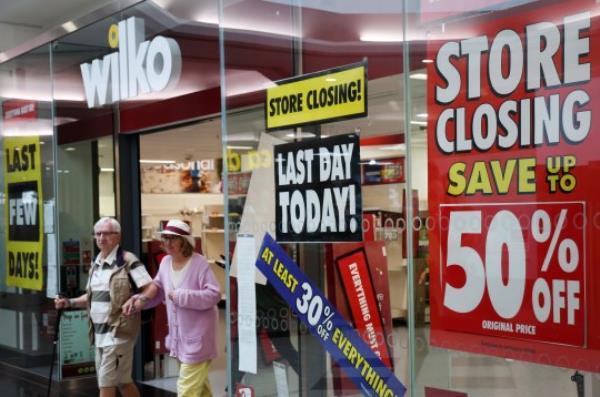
[{"x1": 440, "y1": 202, "x2": 586, "y2": 346}]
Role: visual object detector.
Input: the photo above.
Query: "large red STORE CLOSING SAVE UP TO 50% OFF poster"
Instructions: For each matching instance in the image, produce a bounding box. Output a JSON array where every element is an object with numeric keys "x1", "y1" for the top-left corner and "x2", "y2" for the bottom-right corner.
[{"x1": 427, "y1": 1, "x2": 600, "y2": 372}]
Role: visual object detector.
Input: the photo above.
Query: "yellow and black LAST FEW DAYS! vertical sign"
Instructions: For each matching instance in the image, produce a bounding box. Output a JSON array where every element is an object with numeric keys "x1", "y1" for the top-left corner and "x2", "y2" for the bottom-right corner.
[{"x1": 4, "y1": 136, "x2": 44, "y2": 291}]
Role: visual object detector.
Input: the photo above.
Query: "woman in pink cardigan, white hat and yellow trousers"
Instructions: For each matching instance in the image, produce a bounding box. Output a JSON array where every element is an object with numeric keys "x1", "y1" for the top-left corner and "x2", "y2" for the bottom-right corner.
[{"x1": 123, "y1": 219, "x2": 221, "y2": 397}]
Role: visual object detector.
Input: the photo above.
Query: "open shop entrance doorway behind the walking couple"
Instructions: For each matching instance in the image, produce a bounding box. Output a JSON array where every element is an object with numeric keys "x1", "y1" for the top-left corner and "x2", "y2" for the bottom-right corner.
[{"x1": 139, "y1": 118, "x2": 227, "y2": 395}]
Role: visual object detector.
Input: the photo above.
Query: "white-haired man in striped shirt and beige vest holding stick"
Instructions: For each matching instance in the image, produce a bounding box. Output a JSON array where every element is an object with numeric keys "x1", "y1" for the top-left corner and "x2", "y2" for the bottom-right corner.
[{"x1": 54, "y1": 218, "x2": 152, "y2": 397}]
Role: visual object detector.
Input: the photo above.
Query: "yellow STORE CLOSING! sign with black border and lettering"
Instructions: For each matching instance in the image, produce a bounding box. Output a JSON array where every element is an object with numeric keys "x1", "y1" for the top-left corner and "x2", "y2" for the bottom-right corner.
[{"x1": 265, "y1": 61, "x2": 367, "y2": 130}]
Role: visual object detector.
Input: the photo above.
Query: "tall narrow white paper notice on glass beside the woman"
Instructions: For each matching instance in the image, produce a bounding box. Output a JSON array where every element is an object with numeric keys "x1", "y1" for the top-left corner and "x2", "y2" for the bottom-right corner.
[{"x1": 235, "y1": 234, "x2": 257, "y2": 374}]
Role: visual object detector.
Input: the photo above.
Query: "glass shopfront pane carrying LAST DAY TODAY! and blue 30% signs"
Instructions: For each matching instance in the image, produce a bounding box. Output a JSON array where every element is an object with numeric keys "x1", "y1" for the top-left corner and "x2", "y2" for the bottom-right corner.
[{"x1": 221, "y1": 0, "x2": 410, "y2": 396}]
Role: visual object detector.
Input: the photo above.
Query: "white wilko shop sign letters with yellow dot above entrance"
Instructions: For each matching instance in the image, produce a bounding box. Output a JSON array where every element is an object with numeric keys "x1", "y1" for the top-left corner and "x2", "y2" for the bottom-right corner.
[{"x1": 80, "y1": 17, "x2": 181, "y2": 108}]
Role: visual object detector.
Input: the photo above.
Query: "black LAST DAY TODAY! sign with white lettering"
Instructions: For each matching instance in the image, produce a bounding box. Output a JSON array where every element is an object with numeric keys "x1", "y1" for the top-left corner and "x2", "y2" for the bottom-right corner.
[{"x1": 274, "y1": 134, "x2": 362, "y2": 242}]
